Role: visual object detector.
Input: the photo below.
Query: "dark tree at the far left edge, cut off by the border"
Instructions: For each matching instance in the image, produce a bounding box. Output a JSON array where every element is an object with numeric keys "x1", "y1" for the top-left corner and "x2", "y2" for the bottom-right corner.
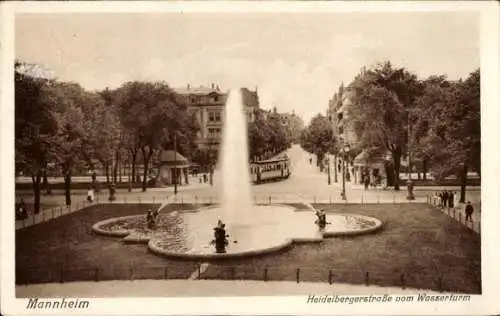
[{"x1": 14, "y1": 61, "x2": 57, "y2": 213}]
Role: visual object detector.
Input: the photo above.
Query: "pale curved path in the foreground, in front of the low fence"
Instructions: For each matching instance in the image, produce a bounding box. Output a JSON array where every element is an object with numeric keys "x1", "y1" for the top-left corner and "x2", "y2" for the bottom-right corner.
[{"x1": 16, "y1": 280, "x2": 446, "y2": 298}]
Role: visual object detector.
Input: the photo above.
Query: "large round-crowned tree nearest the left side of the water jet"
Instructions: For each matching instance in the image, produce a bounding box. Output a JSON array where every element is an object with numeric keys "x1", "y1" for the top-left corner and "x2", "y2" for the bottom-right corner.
[{"x1": 114, "y1": 82, "x2": 197, "y2": 191}]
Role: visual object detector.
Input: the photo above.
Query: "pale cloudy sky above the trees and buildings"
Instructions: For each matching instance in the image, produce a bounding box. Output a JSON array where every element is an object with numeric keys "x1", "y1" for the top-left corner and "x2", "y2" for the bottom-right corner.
[{"x1": 15, "y1": 12, "x2": 480, "y2": 123}]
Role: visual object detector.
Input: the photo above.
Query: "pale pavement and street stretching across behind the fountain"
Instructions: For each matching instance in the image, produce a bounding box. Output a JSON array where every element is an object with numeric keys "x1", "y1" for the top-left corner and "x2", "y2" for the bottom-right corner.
[{"x1": 12, "y1": 145, "x2": 481, "y2": 229}]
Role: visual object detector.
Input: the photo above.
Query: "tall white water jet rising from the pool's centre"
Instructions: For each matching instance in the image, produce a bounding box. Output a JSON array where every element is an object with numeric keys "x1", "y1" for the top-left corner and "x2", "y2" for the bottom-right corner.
[{"x1": 219, "y1": 89, "x2": 253, "y2": 226}]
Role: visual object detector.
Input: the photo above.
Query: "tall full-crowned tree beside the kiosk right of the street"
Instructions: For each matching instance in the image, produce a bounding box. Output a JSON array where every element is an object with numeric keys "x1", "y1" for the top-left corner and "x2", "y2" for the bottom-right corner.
[{"x1": 348, "y1": 62, "x2": 422, "y2": 190}]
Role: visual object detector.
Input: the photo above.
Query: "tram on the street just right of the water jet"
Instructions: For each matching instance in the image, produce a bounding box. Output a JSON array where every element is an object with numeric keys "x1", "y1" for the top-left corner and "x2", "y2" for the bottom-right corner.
[{"x1": 250, "y1": 156, "x2": 291, "y2": 184}]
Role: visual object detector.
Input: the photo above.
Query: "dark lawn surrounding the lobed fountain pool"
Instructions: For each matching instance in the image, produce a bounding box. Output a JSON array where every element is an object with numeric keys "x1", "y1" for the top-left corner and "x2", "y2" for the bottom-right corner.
[{"x1": 16, "y1": 204, "x2": 481, "y2": 293}]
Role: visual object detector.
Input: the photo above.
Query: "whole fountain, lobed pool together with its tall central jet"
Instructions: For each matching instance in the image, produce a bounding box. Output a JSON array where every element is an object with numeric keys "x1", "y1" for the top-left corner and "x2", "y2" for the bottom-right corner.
[{"x1": 93, "y1": 89, "x2": 382, "y2": 259}]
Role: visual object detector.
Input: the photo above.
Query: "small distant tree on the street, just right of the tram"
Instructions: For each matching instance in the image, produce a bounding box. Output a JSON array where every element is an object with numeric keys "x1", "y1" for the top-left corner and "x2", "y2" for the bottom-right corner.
[{"x1": 301, "y1": 114, "x2": 338, "y2": 169}]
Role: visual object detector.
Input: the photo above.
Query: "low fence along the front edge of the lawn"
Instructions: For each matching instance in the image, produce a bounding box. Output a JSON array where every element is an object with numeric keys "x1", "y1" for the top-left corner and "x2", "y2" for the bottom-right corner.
[{"x1": 16, "y1": 262, "x2": 481, "y2": 293}]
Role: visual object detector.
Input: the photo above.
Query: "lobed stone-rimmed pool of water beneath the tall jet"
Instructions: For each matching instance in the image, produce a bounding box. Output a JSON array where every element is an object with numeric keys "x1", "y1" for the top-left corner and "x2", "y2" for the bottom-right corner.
[{"x1": 93, "y1": 205, "x2": 382, "y2": 258}]
